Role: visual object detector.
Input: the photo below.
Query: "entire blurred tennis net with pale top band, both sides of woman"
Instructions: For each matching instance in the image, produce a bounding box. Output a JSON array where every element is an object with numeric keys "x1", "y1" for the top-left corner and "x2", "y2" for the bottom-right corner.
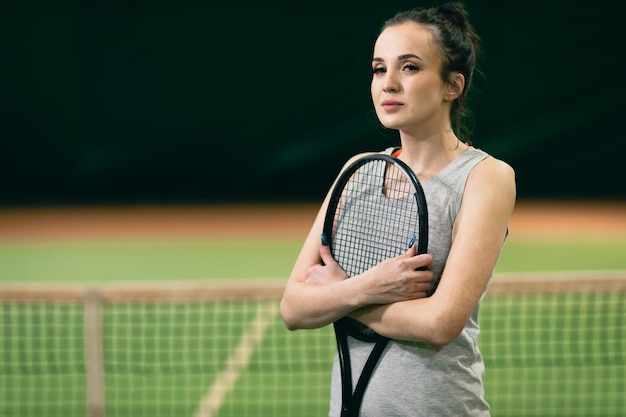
[{"x1": 0, "y1": 276, "x2": 626, "y2": 417}]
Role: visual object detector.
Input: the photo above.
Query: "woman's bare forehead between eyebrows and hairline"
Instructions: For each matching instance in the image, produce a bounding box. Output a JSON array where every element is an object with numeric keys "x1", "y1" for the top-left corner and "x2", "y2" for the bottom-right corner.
[{"x1": 374, "y1": 22, "x2": 439, "y2": 60}]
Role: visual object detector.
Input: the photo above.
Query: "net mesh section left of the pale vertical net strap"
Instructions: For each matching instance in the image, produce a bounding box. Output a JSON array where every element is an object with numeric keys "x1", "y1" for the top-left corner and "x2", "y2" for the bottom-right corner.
[{"x1": 0, "y1": 302, "x2": 86, "y2": 416}]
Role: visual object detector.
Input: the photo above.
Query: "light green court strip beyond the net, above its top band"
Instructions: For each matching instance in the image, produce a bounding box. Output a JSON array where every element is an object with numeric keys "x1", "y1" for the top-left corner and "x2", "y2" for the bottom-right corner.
[{"x1": 0, "y1": 238, "x2": 626, "y2": 283}]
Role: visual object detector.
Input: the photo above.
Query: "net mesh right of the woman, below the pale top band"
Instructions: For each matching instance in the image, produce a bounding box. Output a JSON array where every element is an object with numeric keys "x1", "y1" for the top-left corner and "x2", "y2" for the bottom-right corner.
[{"x1": 479, "y1": 292, "x2": 626, "y2": 416}]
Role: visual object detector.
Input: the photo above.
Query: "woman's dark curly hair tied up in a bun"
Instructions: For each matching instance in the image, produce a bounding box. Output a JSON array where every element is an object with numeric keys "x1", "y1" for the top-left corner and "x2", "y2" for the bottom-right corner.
[{"x1": 381, "y1": 2, "x2": 480, "y2": 142}]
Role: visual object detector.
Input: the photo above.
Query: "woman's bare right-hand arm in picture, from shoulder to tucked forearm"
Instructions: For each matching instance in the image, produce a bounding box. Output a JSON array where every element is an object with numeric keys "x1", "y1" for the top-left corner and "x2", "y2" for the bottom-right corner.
[{"x1": 351, "y1": 158, "x2": 515, "y2": 345}]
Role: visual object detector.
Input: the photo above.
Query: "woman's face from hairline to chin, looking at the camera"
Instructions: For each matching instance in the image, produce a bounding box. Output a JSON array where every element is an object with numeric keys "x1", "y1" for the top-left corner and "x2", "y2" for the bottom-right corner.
[{"x1": 371, "y1": 22, "x2": 451, "y2": 132}]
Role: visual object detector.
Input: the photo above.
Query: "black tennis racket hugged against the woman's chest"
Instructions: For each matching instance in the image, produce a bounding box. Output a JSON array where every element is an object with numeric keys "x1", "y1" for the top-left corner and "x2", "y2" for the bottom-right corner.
[{"x1": 323, "y1": 154, "x2": 428, "y2": 417}]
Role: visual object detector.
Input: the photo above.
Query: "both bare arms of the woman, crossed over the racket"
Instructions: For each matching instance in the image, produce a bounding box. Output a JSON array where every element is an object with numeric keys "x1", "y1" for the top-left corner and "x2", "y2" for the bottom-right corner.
[{"x1": 281, "y1": 158, "x2": 515, "y2": 345}]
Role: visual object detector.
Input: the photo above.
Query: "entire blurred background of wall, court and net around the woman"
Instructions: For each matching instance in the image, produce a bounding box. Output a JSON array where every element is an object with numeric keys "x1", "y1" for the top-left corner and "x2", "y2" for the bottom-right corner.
[{"x1": 0, "y1": 0, "x2": 626, "y2": 417}]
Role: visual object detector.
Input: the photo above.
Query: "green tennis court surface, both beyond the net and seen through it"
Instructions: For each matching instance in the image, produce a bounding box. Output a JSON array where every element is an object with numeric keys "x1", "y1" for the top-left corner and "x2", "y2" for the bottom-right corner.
[{"x1": 0, "y1": 231, "x2": 626, "y2": 417}]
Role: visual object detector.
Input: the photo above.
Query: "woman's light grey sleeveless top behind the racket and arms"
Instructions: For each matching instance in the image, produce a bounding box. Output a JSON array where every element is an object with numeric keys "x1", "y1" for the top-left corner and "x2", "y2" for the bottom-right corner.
[{"x1": 329, "y1": 147, "x2": 491, "y2": 417}]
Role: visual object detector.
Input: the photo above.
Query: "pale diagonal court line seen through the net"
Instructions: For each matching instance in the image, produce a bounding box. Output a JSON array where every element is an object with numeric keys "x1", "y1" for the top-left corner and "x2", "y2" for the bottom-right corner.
[{"x1": 194, "y1": 302, "x2": 278, "y2": 417}]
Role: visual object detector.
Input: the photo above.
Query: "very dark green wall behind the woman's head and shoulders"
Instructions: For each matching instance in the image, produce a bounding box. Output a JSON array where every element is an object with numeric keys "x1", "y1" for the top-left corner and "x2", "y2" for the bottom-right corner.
[{"x1": 0, "y1": 0, "x2": 626, "y2": 205}]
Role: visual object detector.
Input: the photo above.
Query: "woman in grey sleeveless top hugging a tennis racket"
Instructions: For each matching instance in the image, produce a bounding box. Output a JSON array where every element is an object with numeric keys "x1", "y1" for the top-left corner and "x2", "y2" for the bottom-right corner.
[{"x1": 281, "y1": 3, "x2": 515, "y2": 417}]
